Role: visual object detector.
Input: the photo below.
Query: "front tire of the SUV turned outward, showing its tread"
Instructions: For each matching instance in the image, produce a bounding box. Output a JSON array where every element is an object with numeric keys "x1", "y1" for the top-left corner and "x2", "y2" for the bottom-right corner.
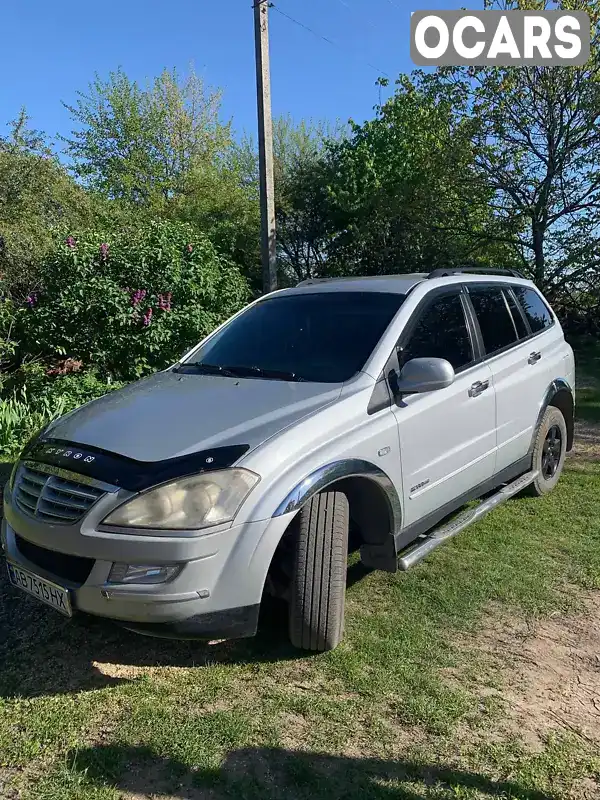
[{"x1": 289, "y1": 491, "x2": 349, "y2": 653}]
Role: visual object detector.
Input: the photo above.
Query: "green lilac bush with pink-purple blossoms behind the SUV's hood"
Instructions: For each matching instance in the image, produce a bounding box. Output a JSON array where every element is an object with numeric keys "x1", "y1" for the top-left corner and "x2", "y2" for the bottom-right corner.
[{"x1": 18, "y1": 222, "x2": 249, "y2": 380}]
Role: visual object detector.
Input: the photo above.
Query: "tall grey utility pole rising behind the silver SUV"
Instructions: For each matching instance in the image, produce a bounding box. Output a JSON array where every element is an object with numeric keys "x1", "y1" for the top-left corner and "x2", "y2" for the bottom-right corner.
[{"x1": 254, "y1": 0, "x2": 277, "y2": 292}]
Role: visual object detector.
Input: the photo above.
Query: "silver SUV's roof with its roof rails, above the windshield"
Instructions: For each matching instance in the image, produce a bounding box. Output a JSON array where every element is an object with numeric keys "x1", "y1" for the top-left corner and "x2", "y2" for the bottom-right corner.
[{"x1": 271, "y1": 270, "x2": 532, "y2": 296}]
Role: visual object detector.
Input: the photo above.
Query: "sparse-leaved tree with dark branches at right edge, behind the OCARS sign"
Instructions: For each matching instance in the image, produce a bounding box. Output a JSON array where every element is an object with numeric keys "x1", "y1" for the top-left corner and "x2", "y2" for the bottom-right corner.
[{"x1": 415, "y1": 0, "x2": 600, "y2": 296}]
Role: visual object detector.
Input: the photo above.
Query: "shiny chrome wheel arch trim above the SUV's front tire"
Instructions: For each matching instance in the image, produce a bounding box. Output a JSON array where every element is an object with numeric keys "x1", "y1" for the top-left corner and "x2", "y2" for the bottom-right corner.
[{"x1": 273, "y1": 458, "x2": 402, "y2": 535}]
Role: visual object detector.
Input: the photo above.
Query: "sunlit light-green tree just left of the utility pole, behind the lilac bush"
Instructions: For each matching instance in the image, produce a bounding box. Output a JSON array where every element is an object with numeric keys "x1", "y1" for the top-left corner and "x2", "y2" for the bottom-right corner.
[{"x1": 66, "y1": 70, "x2": 260, "y2": 282}]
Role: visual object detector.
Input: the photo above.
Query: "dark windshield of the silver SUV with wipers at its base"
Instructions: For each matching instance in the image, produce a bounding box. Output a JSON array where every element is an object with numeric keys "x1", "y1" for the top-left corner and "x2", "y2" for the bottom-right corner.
[{"x1": 185, "y1": 292, "x2": 404, "y2": 383}]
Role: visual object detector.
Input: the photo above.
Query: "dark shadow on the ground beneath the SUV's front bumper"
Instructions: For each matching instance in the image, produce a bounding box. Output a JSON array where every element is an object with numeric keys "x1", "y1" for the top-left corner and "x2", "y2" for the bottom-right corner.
[{"x1": 0, "y1": 558, "x2": 306, "y2": 698}]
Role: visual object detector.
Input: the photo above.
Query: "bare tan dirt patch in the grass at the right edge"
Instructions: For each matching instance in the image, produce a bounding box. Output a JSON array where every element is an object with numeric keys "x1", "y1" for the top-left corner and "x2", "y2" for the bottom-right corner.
[{"x1": 462, "y1": 592, "x2": 600, "y2": 752}]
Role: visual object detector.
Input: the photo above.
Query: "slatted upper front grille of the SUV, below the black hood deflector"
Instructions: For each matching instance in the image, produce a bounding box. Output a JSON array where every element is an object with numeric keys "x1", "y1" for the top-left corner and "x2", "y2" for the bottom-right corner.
[{"x1": 14, "y1": 464, "x2": 105, "y2": 525}]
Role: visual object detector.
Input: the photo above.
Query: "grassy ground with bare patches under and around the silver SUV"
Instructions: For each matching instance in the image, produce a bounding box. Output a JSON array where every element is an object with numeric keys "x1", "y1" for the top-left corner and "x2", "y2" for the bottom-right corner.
[{"x1": 0, "y1": 349, "x2": 600, "y2": 800}]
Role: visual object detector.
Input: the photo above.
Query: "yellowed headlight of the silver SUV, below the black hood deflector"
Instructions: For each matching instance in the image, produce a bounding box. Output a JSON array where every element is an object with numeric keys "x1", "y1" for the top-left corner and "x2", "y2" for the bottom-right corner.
[{"x1": 103, "y1": 469, "x2": 260, "y2": 531}]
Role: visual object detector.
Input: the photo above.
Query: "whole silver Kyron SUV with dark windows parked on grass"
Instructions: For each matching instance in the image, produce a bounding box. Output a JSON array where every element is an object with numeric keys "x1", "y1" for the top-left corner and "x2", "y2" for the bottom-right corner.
[{"x1": 2, "y1": 270, "x2": 575, "y2": 651}]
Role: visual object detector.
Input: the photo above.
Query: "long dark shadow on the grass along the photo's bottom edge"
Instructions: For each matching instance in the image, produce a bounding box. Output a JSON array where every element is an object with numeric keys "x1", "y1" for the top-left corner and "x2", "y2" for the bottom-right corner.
[{"x1": 61, "y1": 745, "x2": 551, "y2": 800}]
